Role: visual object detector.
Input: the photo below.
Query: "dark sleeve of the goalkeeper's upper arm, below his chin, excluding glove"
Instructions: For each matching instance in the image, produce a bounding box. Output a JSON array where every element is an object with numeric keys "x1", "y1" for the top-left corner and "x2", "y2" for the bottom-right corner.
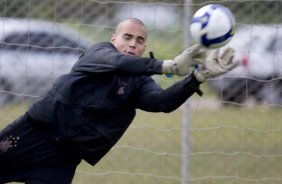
[{"x1": 73, "y1": 42, "x2": 162, "y2": 75}]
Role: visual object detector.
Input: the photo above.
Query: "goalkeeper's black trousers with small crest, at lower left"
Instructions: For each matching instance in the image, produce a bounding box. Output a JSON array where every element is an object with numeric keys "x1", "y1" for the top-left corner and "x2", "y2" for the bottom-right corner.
[{"x1": 0, "y1": 114, "x2": 81, "y2": 184}]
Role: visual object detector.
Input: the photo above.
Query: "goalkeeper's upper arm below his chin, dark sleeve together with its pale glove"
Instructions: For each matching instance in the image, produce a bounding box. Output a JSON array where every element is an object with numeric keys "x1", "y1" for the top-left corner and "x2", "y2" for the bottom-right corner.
[{"x1": 73, "y1": 42, "x2": 202, "y2": 76}]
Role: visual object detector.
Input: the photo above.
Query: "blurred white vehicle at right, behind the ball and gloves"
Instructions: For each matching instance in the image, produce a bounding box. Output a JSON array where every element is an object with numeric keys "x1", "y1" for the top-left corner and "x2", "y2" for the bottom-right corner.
[{"x1": 208, "y1": 25, "x2": 282, "y2": 105}]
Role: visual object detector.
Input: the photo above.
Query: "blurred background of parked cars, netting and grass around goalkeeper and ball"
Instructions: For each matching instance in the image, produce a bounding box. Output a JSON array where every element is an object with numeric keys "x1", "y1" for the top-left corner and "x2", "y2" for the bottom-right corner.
[{"x1": 0, "y1": 0, "x2": 282, "y2": 184}]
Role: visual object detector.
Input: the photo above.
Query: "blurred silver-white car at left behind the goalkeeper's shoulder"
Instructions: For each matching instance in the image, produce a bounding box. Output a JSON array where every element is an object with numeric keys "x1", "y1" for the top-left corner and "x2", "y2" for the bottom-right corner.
[{"x1": 0, "y1": 18, "x2": 91, "y2": 105}]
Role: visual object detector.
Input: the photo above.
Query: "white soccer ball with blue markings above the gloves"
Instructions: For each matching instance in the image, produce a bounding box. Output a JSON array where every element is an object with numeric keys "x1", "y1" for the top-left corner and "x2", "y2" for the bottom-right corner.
[{"x1": 190, "y1": 4, "x2": 235, "y2": 48}]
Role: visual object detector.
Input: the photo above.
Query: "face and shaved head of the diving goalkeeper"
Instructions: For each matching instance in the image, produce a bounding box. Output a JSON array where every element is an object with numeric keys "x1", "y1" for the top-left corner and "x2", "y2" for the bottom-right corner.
[{"x1": 111, "y1": 21, "x2": 147, "y2": 56}]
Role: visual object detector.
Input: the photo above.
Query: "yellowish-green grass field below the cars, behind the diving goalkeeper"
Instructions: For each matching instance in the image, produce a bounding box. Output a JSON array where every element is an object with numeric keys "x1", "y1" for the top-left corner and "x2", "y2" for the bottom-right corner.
[{"x1": 0, "y1": 105, "x2": 282, "y2": 184}]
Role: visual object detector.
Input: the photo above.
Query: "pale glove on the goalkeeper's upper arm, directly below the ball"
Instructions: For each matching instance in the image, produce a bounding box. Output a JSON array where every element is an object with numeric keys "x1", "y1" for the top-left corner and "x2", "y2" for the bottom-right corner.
[{"x1": 162, "y1": 44, "x2": 204, "y2": 76}]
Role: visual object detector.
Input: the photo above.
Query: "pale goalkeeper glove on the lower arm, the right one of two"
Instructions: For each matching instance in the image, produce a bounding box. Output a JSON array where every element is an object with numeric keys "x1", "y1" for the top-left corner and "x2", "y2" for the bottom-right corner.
[{"x1": 194, "y1": 47, "x2": 239, "y2": 82}]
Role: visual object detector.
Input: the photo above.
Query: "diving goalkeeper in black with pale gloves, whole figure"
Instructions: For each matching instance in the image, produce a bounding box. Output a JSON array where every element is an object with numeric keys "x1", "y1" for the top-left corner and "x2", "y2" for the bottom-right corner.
[{"x1": 0, "y1": 18, "x2": 237, "y2": 184}]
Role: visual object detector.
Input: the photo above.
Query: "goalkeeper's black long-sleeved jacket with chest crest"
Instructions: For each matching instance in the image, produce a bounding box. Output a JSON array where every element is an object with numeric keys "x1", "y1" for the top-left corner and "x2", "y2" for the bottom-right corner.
[{"x1": 28, "y1": 42, "x2": 200, "y2": 165}]
